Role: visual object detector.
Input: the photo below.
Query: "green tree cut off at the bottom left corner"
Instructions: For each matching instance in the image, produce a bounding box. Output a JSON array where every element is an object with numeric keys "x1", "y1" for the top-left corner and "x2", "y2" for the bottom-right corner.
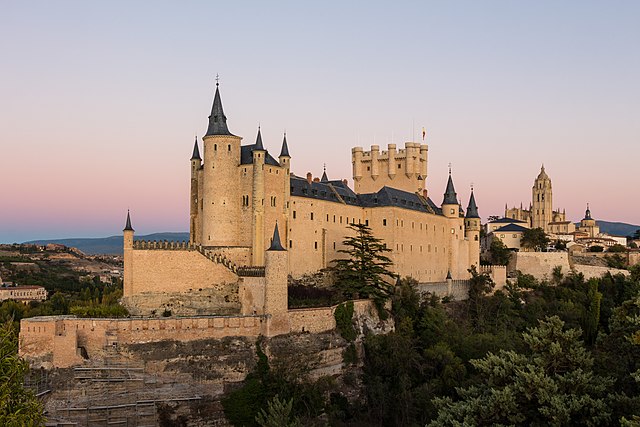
[{"x1": 0, "y1": 322, "x2": 45, "y2": 427}]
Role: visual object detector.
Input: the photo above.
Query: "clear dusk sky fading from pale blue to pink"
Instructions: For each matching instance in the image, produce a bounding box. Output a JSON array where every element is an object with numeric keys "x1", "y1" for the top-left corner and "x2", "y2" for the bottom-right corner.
[{"x1": 0, "y1": 0, "x2": 640, "y2": 243}]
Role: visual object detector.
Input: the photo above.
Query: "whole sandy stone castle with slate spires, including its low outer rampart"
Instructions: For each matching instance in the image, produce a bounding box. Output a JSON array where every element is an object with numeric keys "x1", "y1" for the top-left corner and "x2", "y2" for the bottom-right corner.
[{"x1": 20, "y1": 84, "x2": 484, "y2": 366}]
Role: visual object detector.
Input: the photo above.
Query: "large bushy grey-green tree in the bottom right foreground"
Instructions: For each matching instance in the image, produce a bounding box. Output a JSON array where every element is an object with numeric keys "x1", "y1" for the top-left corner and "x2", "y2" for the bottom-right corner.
[{"x1": 430, "y1": 316, "x2": 612, "y2": 426}]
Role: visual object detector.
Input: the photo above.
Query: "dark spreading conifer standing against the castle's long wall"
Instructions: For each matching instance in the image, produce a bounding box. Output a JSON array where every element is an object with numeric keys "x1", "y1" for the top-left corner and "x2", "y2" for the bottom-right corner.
[{"x1": 332, "y1": 224, "x2": 396, "y2": 309}]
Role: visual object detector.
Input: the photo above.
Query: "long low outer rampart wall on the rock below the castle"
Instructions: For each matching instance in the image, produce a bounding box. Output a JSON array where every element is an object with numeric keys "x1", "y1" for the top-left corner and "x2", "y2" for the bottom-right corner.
[{"x1": 19, "y1": 300, "x2": 375, "y2": 369}]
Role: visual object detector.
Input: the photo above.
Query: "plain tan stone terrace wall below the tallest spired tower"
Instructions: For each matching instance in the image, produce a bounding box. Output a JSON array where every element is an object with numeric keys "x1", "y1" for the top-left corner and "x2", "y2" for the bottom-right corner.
[{"x1": 124, "y1": 249, "x2": 238, "y2": 297}]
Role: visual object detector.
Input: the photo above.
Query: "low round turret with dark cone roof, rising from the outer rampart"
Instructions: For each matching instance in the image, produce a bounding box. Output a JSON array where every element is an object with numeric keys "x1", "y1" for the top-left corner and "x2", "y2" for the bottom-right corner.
[{"x1": 264, "y1": 223, "x2": 290, "y2": 336}]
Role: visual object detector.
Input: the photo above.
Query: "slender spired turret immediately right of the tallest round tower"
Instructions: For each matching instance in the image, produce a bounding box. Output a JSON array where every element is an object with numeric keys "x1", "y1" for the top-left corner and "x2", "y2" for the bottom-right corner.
[{"x1": 251, "y1": 126, "x2": 267, "y2": 266}]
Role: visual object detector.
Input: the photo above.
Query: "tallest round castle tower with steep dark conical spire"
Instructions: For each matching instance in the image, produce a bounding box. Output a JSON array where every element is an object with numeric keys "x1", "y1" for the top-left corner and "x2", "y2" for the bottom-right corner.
[{"x1": 196, "y1": 83, "x2": 242, "y2": 246}]
